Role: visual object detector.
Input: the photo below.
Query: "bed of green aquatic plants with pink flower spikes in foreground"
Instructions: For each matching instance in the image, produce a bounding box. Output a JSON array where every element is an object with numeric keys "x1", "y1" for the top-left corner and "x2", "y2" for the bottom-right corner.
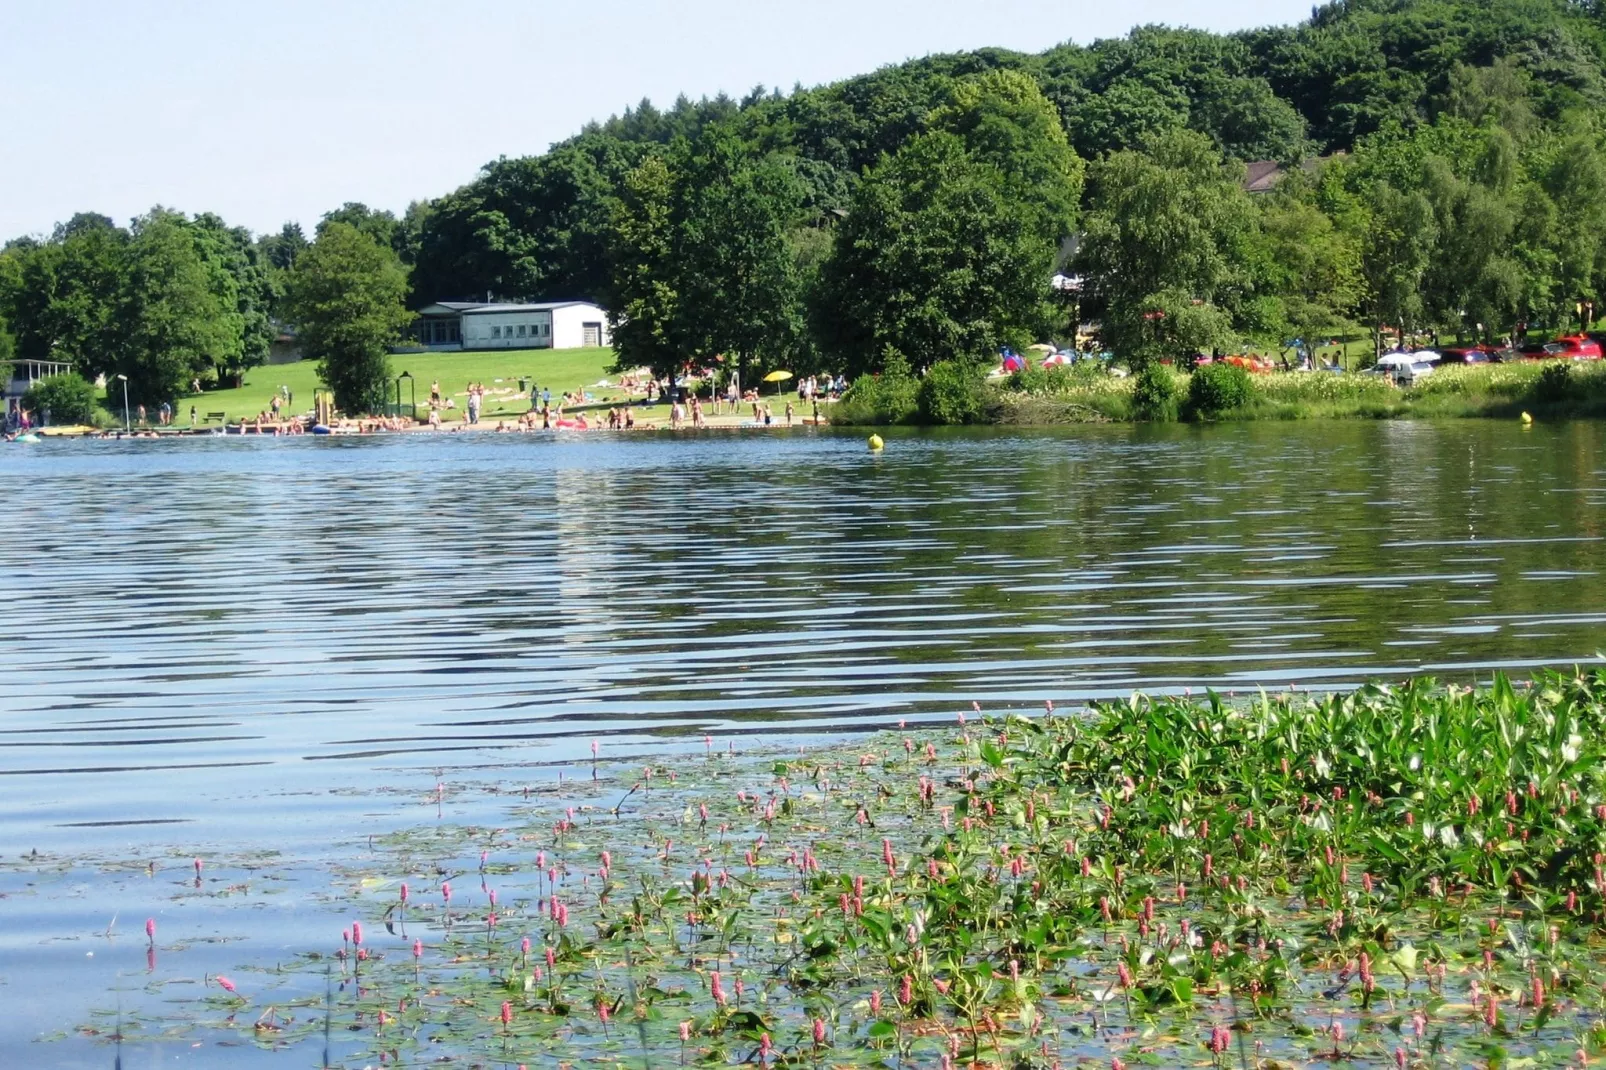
[{"x1": 85, "y1": 673, "x2": 1606, "y2": 1068}]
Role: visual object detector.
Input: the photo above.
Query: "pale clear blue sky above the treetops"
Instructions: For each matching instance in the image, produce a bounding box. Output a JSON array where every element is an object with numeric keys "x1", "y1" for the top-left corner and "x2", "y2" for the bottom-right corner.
[{"x1": 0, "y1": 0, "x2": 1310, "y2": 241}]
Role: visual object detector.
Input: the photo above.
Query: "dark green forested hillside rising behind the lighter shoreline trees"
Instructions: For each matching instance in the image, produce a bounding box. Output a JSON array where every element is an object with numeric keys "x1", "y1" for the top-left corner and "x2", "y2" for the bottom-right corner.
[{"x1": 414, "y1": 0, "x2": 1606, "y2": 306}]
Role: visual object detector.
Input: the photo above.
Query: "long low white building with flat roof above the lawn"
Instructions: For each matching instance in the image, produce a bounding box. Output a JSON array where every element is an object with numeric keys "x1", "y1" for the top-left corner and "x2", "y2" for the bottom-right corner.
[{"x1": 413, "y1": 300, "x2": 610, "y2": 350}]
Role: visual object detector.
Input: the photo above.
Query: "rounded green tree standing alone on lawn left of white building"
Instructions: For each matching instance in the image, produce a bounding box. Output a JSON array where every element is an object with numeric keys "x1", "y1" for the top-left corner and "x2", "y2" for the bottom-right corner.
[{"x1": 286, "y1": 222, "x2": 413, "y2": 413}]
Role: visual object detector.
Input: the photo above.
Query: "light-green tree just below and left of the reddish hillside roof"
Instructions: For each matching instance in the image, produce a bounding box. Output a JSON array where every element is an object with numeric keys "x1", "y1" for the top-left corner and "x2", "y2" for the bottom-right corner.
[{"x1": 1076, "y1": 130, "x2": 1256, "y2": 365}]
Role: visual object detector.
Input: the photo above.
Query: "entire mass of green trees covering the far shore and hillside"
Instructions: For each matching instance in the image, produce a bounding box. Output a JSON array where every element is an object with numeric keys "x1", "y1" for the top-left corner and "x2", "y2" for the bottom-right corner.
[{"x1": 9, "y1": 0, "x2": 1606, "y2": 408}]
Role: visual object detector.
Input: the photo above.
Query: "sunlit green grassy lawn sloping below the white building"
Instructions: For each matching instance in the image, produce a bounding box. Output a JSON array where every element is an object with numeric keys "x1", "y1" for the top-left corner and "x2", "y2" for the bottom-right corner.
[{"x1": 144, "y1": 349, "x2": 617, "y2": 426}]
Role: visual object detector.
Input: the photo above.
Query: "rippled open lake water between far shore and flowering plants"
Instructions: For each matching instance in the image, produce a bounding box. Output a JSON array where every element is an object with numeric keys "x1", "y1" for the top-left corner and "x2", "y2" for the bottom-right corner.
[{"x1": 0, "y1": 421, "x2": 1606, "y2": 1067}]
